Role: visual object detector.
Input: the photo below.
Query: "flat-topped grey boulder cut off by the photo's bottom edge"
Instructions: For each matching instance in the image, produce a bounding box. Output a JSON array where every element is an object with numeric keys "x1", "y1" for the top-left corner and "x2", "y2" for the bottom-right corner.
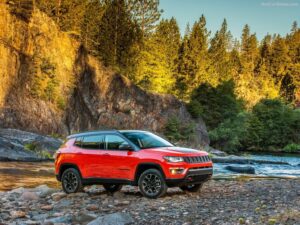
[{"x1": 88, "y1": 213, "x2": 134, "y2": 225}]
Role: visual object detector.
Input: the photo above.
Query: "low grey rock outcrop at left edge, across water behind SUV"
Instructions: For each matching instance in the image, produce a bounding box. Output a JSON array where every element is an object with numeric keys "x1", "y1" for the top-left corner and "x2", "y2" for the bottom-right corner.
[{"x1": 0, "y1": 129, "x2": 62, "y2": 161}]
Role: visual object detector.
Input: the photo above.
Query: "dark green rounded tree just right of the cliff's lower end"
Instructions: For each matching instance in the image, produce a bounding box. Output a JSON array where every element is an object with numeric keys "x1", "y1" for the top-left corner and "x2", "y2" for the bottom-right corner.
[{"x1": 188, "y1": 80, "x2": 243, "y2": 129}]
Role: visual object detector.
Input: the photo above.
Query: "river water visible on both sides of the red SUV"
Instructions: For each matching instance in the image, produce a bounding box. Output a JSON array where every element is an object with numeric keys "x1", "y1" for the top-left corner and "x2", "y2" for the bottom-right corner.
[{"x1": 0, "y1": 155, "x2": 300, "y2": 191}]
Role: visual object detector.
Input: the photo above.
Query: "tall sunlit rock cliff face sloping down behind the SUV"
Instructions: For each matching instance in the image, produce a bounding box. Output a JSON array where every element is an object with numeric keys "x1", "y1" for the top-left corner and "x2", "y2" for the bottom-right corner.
[{"x1": 0, "y1": 0, "x2": 209, "y2": 146}]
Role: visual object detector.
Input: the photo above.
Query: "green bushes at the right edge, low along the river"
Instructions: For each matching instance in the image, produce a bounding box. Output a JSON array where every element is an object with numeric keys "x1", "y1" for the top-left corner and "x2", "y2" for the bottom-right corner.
[{"x1": 209, "y1": 99, "x2": 300, "y2": 152}]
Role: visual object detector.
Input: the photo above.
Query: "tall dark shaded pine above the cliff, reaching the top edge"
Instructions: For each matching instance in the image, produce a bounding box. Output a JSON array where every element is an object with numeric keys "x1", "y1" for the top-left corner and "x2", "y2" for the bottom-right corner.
[{"x1": 98, "y1": 0, "x2": 139, "y2": 70}]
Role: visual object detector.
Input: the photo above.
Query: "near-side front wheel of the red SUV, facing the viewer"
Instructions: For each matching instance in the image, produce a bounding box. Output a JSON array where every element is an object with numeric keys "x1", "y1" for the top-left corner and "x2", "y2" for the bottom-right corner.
[{"x1": 138, "y1": 169, "x2": 168, "y2": 198}]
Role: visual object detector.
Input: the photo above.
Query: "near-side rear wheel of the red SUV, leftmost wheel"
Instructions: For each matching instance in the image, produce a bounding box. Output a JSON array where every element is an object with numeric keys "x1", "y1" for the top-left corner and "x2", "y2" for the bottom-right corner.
[{"x1": 61, "y1": 168, "x2": 83, "y2": 194}]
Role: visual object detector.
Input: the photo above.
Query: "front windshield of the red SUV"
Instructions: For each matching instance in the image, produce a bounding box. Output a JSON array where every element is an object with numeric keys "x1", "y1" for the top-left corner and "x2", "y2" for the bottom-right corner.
[{"x1": 122, "y1": 132, "x2": 174, "y2": 149}]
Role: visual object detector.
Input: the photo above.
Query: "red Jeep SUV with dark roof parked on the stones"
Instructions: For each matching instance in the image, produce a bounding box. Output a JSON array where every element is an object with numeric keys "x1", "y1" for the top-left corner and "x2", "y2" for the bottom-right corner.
[{"x1": 55, "y1": 130, "x2": 213, "y2": 198}]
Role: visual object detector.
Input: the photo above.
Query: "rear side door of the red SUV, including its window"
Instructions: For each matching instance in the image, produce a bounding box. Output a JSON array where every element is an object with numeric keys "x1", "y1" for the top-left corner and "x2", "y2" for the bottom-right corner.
[{"x1": 80, "y1": 134, "x2": 107, "y2": 178}]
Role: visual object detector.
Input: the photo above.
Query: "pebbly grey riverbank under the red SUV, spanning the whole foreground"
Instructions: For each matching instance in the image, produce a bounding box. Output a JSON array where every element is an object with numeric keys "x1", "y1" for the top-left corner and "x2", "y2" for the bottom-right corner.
[{"x1": 0, "y1": 179, "x2": 300, "y2": 225}]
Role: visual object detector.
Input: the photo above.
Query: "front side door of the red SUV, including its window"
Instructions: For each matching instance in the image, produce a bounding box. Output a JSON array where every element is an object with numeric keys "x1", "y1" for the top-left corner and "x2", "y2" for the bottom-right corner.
[{"x1": 105, "y1": 134, "x2": 137, "y2": 180}]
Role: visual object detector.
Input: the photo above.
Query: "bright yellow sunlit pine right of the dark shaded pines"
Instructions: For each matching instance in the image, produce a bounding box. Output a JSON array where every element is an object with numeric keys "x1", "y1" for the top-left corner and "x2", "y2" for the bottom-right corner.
[{"x1": 137, "y1": 18, "x2": 180, "y2": 93}]
